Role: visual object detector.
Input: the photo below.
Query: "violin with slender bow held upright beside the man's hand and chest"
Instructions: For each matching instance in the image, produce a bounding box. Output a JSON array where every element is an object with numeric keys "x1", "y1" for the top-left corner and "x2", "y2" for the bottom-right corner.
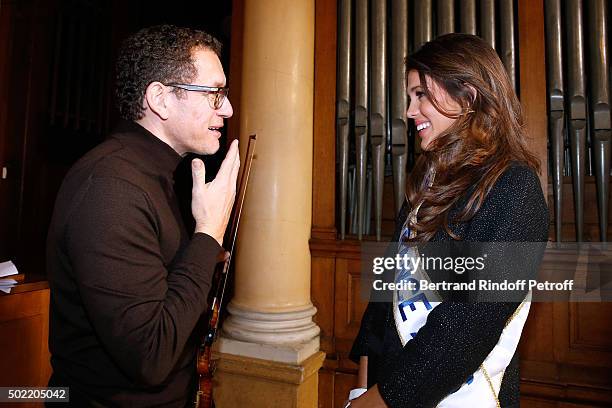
[{"x1": 194, "y1": 135, "x2": 257, "y2": 408}]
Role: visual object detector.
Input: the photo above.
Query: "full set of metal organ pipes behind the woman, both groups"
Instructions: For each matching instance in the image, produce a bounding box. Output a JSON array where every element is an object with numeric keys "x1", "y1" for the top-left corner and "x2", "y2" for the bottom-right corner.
[{"x1": 336, "y1": 0, "x2": 612, "y2": 241}]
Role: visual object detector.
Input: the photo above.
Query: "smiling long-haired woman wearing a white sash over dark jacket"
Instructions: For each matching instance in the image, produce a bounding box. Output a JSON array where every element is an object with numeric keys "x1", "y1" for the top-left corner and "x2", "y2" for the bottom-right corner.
[{"x1": 350, "y1": 34, "x2": 548, "y2": 408}]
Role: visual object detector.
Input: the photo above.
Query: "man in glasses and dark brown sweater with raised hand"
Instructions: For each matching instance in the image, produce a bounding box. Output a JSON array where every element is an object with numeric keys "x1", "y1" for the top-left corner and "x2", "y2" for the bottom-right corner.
[{"x1": 47, "y1": 25, "x2": 239, "y2": 407}]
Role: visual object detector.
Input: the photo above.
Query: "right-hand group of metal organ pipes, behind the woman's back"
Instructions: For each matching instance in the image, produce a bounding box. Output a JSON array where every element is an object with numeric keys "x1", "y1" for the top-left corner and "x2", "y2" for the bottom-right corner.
[{"x1": 545, "y1": 0, "x2": 612, "y2": 242}]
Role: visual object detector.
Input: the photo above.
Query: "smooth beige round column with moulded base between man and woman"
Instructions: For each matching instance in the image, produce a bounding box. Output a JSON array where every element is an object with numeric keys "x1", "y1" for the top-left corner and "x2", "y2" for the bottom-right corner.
[{"x1": 215, "y1": 0, "x2": 323, "y2": 408}]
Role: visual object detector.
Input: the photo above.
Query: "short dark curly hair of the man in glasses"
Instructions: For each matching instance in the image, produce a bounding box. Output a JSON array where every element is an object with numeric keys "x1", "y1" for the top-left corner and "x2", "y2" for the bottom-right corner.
[{"x1": 115, "y1": 25, "x2": 221, "y2": 120}]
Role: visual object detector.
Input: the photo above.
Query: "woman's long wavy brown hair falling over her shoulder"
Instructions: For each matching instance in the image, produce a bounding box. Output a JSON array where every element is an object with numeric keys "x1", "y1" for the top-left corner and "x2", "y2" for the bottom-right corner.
[{"x1": 406, "y1": 34, "x2": 540, "y2": 241}]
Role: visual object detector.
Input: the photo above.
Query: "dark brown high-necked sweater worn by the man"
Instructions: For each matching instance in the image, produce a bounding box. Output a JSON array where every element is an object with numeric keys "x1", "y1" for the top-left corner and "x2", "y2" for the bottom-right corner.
[{"x1": 47, "y1": 122, "x2": 221, "y2": 407}]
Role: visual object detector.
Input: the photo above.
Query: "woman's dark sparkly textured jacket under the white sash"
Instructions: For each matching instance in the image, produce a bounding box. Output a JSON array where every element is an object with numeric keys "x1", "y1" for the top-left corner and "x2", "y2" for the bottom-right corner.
[{"x1": 350, "y1": 163, "x2": 548, "y2": 408}]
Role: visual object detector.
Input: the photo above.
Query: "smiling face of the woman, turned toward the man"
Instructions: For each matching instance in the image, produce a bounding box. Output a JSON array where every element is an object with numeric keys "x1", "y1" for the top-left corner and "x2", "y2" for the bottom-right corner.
[{"x1": 407, "y1": 70, "x2": 461, "y2": 150}]
